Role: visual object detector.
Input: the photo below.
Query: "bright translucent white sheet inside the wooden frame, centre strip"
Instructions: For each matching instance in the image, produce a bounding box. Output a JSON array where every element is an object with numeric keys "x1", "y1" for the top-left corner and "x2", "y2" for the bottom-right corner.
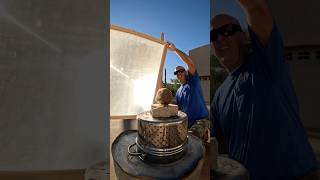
[{"x1": 110, "y1": 29, "x2": 165, "y2": 116}]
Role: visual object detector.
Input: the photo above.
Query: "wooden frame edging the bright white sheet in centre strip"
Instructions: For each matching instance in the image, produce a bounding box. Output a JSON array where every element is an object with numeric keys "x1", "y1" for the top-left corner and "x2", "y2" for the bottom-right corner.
[{"x1": 110, "y1": 24, "x2": 167, "y2": 120}]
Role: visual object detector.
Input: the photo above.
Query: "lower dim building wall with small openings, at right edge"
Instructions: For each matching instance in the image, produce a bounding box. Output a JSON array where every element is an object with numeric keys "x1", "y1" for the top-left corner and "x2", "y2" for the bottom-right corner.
[{"x1": 287, "y1": 46, "x2": 320, "y2": 131}]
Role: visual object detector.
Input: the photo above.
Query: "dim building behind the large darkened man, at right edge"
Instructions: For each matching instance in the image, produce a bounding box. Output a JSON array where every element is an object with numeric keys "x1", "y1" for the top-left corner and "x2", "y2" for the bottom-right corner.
[{"x1": 268, "y1": 0, "x2": 320, "y2": 132}]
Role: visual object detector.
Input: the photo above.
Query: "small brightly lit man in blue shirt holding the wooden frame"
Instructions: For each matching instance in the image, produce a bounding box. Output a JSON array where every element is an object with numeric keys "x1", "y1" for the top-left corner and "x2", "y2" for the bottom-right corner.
[{"x1": 168, "y1": 43, "x2": 209, "y2": 128}]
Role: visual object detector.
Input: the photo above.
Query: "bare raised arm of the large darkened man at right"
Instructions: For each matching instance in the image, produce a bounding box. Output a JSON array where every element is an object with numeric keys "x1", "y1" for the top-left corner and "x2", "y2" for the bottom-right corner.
[{"x1": 238, "y1": 0, "x2": 273, "y2": 45}]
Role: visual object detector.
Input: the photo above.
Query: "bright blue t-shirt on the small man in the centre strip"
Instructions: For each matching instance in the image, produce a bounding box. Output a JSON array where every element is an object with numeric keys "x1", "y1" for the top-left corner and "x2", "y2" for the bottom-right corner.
[{"x1": 176, "y1": 71, "x2": 209, "y2": 128}]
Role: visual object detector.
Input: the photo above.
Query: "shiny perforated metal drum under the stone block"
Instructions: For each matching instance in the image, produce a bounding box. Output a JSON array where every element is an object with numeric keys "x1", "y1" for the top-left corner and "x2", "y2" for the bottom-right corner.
[{"x1": 128, "y1": 111, "x2": 188, "y2": 162}]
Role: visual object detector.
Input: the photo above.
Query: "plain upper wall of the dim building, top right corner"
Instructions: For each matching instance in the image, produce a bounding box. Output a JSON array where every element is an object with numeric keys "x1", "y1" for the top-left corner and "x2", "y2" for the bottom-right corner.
[{"x1": 268, "y1": 0, "x2": 320, "y2": 46}]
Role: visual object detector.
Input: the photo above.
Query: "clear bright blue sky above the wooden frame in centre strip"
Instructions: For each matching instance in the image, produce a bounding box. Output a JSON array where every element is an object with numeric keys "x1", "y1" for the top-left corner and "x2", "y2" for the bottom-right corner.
[{"x1": 110, "y1": 0, "x2": 210, "y2": 82}]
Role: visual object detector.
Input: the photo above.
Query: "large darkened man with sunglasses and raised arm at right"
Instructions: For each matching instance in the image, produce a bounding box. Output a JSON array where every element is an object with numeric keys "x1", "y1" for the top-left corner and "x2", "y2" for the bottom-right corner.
[{"x1": 210, "y1": 0, "x2": 317, "y2": 180}]
